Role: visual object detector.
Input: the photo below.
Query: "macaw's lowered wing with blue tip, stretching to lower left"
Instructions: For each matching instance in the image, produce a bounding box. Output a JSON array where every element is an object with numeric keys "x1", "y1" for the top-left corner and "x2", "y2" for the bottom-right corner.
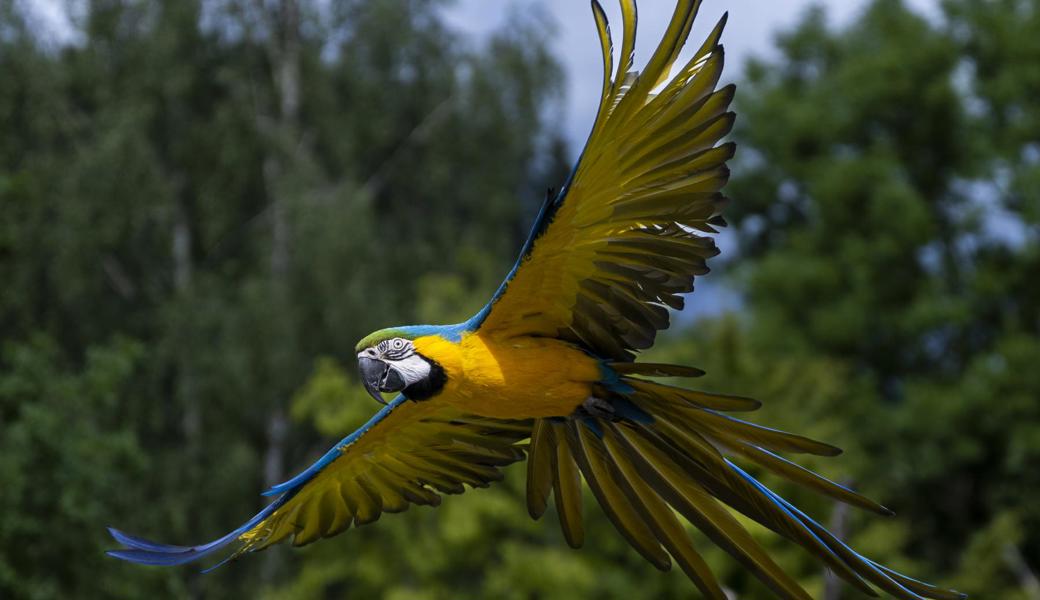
[{"x1": 108, "y1": 396, "x2": 531, "y2": 565}]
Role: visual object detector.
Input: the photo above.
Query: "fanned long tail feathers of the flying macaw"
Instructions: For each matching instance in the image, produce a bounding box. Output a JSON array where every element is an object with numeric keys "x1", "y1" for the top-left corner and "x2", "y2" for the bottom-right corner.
[{"x1": 527, "y1": 376, "x2": 964, "y2": 600}]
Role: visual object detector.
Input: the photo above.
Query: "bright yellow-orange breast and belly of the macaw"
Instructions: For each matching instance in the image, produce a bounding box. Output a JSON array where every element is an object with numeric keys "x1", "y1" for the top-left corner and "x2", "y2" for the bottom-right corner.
[{"x1": 407, "y1": 334, "x2": 601, "y2": 419}]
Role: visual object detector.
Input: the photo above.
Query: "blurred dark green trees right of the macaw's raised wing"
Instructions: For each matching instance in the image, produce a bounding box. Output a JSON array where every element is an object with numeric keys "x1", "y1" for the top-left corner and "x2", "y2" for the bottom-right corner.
[{"x1": 731, "y1": 0, "x2": 1040, "y2": 598}]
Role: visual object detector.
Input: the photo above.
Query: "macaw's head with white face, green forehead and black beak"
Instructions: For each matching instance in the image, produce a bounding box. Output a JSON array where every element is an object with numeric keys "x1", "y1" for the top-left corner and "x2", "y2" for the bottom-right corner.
[{"x1": 355, "y1": 330, "x2": 445, "y2": 403}]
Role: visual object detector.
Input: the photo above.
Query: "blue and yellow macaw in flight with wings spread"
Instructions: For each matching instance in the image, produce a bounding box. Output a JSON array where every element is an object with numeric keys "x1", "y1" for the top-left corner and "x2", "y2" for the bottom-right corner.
[{"x1": 109, "y1": 0, "x2": 963, "y2": 600}]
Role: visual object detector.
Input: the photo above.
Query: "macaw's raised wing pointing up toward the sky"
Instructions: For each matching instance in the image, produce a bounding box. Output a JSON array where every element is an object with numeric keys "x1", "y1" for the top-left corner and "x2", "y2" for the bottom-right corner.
[{"x1": 470, "y1": 0, "x2": 734, "y2": 360}]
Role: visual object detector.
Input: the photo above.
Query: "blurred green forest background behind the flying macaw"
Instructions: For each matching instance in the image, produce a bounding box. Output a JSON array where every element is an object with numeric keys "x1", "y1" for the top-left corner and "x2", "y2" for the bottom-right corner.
[{"x1": 0, "y1": 0, "x2": 1040, "y2": 600}]
